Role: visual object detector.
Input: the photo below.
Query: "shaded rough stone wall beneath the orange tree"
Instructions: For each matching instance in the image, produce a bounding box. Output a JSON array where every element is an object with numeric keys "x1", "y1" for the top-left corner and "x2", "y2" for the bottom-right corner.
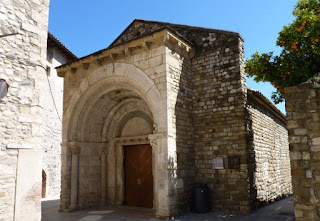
[{"x1": 285, "y1": 83, "x2": 320, "y2": 221}]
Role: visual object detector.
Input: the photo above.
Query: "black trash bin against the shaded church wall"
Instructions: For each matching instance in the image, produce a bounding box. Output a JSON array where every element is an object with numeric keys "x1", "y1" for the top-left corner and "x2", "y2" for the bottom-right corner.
[{"x1": 193, "y1": 183, "x2": 210, "y2": 213}]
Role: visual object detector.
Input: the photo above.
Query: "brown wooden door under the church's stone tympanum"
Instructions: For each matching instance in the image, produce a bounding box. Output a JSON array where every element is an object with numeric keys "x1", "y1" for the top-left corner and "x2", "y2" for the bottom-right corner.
[{"x1": 124, "y1": 144, "x2": 153, "y2": 208}]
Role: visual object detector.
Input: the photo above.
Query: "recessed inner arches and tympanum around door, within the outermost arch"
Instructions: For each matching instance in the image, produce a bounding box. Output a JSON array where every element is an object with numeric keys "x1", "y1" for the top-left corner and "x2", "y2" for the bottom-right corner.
[{"x1": 76, "y1": 89, "x2": 153, "y2": 208}]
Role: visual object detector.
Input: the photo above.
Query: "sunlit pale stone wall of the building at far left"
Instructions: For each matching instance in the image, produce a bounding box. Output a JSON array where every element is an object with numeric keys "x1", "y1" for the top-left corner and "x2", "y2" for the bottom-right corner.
[{"x1": 0, "y1": 0, "x2": 49, "y2": 220}]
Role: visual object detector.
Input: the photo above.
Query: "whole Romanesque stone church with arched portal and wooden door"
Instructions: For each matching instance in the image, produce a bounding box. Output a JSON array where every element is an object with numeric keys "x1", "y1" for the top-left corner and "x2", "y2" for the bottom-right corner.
[{"x1": 58, "y1": 20, "x2": 292, "y2": 217}]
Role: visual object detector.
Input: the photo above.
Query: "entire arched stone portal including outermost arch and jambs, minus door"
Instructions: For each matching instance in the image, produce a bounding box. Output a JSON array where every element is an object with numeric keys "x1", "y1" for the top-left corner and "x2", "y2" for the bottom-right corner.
[{"x1": 61, "y1": 64, "x2": 168, "y2": 217}]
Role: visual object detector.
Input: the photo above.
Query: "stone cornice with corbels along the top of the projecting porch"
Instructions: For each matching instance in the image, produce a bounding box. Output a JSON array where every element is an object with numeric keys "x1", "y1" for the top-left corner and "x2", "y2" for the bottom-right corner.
[{"x1": 57, "y1": 29, "x2": 194, "y2": 77}]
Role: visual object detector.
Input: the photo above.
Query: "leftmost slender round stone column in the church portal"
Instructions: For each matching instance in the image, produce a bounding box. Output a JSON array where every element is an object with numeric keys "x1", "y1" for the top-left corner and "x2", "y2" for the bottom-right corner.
[{"x1": 69, "y1": 146, "x2": 80, "y2": 210}]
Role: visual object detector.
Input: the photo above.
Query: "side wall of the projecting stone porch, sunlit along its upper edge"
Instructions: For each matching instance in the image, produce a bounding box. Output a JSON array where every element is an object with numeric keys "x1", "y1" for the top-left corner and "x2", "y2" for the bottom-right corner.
[{"x1": 166, "y1": 48, "x2": 195, "y2": 214}]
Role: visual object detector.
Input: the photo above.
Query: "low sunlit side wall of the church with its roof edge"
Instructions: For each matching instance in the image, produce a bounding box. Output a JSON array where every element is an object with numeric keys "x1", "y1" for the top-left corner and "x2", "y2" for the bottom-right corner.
[{"x1": 247, "y1": 90, "x2": 292, "y2": 208}]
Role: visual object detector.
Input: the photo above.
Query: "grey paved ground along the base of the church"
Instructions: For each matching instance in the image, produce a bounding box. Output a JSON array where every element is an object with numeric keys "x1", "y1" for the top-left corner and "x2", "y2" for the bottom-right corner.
[{"x1": 42, "y1": 196, "x2": 295, "y2": 221}]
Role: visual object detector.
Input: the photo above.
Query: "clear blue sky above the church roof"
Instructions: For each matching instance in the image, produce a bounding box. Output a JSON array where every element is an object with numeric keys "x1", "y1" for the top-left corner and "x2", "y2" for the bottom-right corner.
[{"x1": 49, "y1": 0, "x2": 296, "y2": 112}]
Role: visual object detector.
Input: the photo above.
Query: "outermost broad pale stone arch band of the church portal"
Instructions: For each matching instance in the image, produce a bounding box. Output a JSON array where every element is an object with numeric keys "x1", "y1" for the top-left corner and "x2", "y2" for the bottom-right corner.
[{"x1": 63, "y1": 63, "x2": 166, "y2": 142}]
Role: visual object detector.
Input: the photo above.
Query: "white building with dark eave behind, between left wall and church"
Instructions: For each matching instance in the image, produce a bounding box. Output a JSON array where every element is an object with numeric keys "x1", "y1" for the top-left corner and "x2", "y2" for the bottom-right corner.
[{"x1": 41, "y1": 33, "x2": 77, "y2": 199}]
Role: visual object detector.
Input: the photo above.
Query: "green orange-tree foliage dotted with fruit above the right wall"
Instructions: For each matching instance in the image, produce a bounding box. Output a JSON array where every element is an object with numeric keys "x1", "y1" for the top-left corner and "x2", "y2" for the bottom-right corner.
[{"x1": 245, "y1": 0, "x2": 320, "y2": 104}]
